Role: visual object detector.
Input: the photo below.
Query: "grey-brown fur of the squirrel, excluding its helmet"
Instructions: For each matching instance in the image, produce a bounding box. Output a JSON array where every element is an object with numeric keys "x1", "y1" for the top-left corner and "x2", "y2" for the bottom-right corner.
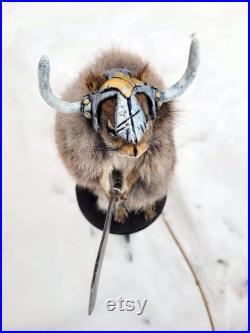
[{"x1": 55, "y1": 50, "x2": 175, "y2": 220}]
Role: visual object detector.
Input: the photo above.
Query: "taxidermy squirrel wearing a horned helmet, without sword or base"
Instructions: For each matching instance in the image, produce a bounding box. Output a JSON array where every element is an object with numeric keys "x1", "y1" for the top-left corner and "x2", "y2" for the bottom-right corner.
[{"x1": 38, "y1": 38, "x2": 199, "y2": 222}]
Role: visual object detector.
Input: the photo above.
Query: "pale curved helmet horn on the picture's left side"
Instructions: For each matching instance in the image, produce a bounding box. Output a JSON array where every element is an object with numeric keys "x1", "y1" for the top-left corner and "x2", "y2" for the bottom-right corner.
[{"x1": 38, "y1": 56, "x2": 81, "y2": 113}]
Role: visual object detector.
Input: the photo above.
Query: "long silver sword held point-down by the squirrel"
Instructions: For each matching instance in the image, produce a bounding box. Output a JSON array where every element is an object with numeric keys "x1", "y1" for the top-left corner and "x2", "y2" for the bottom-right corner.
[{"x1": 88, "y1": 169, "x2": 122, "y2": 316}]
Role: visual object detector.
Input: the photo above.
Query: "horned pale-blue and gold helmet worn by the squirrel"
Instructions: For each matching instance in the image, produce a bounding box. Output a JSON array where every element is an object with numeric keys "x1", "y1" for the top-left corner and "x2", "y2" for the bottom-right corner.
[{"x1": 38, "y1": 37, "x2": 200, "y2": 144}]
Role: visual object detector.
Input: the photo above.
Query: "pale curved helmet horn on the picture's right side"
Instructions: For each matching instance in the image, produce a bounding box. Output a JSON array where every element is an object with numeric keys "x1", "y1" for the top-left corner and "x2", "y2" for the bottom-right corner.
[{"x1": 162, "y1": 37, "x2": 200, "y2": 102}]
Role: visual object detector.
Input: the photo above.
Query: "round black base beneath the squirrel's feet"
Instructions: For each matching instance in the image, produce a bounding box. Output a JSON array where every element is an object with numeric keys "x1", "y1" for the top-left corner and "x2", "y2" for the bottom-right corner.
[{"x1": 76, "y1": 185, "x2": 166, "y2": 235}]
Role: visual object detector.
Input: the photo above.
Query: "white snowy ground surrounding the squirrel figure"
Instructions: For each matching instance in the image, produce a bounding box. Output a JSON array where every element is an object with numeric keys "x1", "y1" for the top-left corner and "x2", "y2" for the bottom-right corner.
[{"x1": 2, "y1": 3, "x2": 248, "y2": 330}]
